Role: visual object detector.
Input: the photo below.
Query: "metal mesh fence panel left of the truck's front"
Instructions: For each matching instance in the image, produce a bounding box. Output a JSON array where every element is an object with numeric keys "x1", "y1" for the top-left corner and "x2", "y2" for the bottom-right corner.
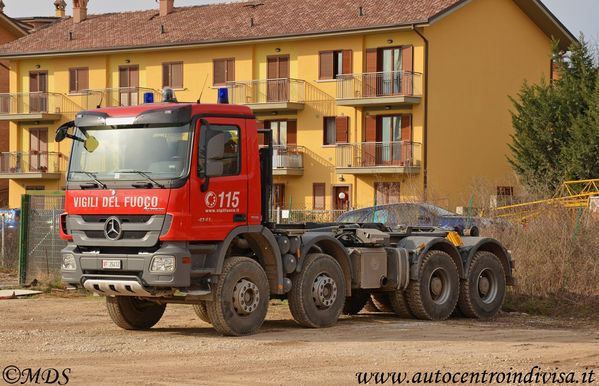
[{"x1": 19, "y1": 194, "x2": 66, "y2": 284}]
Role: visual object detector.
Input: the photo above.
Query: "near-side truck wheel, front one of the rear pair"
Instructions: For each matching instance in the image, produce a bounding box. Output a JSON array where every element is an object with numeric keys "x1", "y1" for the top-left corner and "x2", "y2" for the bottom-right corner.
[{"x1": 407, "y1": 251, "x2": 460, "y2": 320}]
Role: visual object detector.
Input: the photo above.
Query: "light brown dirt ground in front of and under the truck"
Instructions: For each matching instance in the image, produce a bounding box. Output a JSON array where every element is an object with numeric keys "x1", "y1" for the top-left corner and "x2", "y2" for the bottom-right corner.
[{"x1": 0, "y1": 294, "x2": 599, "y2": 385}]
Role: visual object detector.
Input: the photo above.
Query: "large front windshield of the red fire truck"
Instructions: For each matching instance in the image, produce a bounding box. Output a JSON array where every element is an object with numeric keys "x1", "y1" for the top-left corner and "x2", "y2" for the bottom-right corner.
[{"x1": 68, "y1": 124, "x2": 191, "y2": 181}]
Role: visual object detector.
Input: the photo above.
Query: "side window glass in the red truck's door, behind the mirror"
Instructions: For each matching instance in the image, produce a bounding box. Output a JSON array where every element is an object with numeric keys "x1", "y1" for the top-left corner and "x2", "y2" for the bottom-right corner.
[{"x1": 198, "y1": 124, "x2": 241, "y2": 177}]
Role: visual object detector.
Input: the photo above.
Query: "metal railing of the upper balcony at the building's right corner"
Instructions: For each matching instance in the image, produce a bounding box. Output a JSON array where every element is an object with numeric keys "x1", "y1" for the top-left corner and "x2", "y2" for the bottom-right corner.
[{"x1": 337, "y1": 71, "x2": 422, "y2": 99}]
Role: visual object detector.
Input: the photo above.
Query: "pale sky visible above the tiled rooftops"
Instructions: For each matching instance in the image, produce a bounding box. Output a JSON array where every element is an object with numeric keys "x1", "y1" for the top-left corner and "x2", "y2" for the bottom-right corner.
[{"x1": 3, "y1": 0, "x2": 599, "y2": 46}]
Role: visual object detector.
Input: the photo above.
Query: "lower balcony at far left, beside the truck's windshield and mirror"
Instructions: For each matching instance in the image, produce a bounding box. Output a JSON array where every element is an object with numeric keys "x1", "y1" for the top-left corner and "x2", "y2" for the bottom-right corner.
[{"x1": 0, "y1": 151, "x2": 68, "y2": 180}]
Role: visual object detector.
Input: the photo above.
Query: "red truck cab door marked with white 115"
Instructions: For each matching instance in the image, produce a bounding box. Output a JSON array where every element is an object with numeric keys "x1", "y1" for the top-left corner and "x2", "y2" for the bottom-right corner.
[{"x1": 190, "y1": 118, "x2": 248, "y2": 240}]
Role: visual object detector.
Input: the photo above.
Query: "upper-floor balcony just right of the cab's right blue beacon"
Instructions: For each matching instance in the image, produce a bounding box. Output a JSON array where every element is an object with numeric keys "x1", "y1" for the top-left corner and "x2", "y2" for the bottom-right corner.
[{"x1": 228, "y1": 78, "x2": 306, "y2": 111}]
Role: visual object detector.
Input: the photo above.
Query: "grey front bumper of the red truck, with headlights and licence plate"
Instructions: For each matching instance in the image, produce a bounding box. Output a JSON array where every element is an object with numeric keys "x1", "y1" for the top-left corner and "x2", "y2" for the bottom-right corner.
[{"x1": 61, "y1": 242, "x2": 191, "y2": 296}]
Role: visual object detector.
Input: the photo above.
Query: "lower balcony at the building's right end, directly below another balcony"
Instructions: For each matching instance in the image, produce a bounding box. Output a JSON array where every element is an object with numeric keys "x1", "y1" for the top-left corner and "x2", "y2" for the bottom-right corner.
[{"x1": 335, "y1": 141, "x2": 421, "y2": 174}]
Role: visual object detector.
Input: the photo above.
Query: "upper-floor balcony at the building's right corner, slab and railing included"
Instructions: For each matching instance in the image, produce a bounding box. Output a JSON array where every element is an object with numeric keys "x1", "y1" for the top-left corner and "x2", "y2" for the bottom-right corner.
[{"x1": 337, "y1": 71, "x2": 422, "y2": 107}]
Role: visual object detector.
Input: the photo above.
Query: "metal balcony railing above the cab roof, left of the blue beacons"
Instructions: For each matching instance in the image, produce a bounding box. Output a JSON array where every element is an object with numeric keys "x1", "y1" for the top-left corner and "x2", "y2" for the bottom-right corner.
[{"x1": 83, "y1": 87, "x2": 161, "y2": 110}]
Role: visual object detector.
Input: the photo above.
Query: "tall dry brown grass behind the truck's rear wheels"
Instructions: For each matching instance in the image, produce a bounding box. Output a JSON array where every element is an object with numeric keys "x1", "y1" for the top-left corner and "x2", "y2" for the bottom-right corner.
[{"x1": 483, "y1": 207, "x2": 599, "y2": 317}]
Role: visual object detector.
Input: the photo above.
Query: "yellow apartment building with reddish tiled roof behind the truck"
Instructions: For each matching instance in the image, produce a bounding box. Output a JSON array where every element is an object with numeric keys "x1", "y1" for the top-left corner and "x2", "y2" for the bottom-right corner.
[{"x1": 0, "y1": 0, "x2": 575, "y2": 210}]
